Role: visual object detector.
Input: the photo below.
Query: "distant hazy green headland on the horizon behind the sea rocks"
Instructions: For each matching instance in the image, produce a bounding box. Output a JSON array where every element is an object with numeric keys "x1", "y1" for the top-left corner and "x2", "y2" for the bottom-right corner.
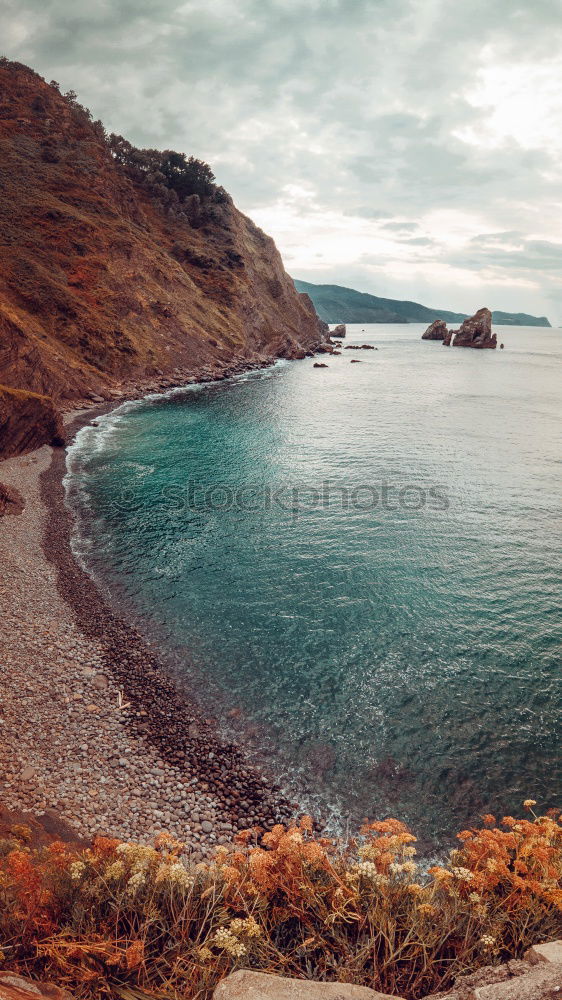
[{"x1": 295, "y1": 280, "x2": 550, "y2": 327}]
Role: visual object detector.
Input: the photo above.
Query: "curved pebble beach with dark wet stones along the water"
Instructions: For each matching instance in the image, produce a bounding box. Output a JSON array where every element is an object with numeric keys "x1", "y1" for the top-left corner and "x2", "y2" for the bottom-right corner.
[{"x1": 0, "y1": 362, "x2": 304, "y2": 860}]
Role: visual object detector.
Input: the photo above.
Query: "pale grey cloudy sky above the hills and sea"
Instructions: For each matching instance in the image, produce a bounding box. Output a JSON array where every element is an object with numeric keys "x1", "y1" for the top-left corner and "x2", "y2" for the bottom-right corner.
[{"x1": 4, "y1": 0, "x2": 562, "y2": 325}]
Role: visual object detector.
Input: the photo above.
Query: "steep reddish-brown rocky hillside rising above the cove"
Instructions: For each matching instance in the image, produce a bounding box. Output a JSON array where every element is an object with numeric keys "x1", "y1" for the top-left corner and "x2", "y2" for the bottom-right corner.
[{"x1": 0, "y1": 60, "x2": 325, "y2": 455}]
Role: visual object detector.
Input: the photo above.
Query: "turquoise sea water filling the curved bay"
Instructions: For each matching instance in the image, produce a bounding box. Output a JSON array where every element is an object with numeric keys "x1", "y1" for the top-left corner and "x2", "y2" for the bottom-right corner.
[{"x1": 67, "y1": 325, "x2": 562, "y2": 839}]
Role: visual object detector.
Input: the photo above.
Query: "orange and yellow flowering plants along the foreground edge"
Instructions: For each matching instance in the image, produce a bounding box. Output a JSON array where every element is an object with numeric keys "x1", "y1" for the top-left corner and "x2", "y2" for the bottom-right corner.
[{"x1": 0, "y1": 800, "x2": 562, "y2": 1000}]
